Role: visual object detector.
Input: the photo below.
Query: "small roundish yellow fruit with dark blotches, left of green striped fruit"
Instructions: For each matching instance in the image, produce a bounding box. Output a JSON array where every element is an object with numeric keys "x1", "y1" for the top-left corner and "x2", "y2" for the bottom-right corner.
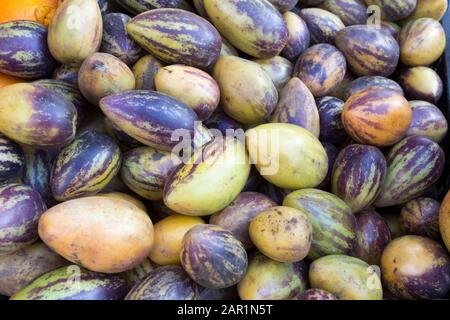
[{"x1": 249, "y1": 207, "x2": 312, "y2": 263}]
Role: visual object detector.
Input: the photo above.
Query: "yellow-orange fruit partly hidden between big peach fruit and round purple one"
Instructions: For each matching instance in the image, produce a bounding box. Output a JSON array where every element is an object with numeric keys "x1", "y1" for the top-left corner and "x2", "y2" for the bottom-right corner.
[{"x1": 149, "y1": 215, "x2": 205, "y2": 266}]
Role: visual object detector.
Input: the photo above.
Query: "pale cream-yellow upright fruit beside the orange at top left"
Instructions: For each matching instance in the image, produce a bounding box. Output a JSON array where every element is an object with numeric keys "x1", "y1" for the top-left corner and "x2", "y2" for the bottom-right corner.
[{"x1": 48, "y1": 0, "x2": 103, "y2": 65}]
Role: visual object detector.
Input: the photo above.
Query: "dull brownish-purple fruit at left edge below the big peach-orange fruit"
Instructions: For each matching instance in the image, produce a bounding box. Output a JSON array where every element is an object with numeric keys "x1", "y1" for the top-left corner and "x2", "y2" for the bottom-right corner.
[{"x1": 0, "y1": 241, "x2": 69, "y2": 297}]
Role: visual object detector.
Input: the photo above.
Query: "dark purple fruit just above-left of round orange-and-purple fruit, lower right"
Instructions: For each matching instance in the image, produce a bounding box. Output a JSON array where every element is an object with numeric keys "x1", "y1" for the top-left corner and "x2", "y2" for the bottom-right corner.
[{"x1": 353, "y1": 210, "x2": 392, "y2": 266}]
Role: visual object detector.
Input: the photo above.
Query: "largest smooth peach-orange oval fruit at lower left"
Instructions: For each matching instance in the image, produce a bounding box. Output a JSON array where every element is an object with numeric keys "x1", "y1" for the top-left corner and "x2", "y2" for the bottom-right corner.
[{"x1": 39, "y1": 197, "x2": 153, "y2": 273}]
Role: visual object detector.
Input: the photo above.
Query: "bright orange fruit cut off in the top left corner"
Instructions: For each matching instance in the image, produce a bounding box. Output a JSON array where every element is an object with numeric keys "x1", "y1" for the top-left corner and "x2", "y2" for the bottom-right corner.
[{"x1": 0, "y1": 0, "x2": 58, "y2": 26}]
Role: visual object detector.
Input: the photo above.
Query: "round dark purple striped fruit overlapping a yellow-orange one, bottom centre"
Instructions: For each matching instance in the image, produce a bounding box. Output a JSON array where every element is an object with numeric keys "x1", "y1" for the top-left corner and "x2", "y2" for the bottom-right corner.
[{"x1": 181, "y1": 225, "x2": 248, "y2": 289}]
